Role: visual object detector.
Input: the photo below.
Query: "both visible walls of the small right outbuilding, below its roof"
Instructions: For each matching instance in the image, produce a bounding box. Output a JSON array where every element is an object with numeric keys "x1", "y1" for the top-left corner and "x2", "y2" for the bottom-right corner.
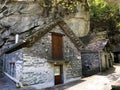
[{"x1": 81, "y1": 51, "x2": 113, "y2": 76}]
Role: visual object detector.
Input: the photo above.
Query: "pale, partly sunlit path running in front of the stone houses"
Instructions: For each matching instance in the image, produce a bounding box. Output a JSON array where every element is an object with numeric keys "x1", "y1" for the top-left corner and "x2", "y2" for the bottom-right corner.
[{"x1": 0, "y1": 64, "x2": 120, "y2": 90}]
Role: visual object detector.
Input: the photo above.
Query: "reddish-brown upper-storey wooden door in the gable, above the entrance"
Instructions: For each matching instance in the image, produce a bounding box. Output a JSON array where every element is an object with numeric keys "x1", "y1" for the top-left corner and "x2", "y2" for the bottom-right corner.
[{"x1": 52, "y1": 33, "x2": 63, "y2": 59}]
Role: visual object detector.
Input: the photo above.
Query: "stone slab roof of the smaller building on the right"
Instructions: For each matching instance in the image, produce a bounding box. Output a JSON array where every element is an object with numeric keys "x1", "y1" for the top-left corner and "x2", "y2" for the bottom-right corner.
[{"x1": 80, "y1": 31, "x2": 108, "y2": 52}]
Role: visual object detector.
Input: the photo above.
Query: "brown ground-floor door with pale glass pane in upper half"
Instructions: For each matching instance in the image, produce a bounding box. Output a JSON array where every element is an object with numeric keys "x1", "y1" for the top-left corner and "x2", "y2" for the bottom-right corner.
[{"x1": 54, "y1": 65, "x2": 63, "y2": 85}]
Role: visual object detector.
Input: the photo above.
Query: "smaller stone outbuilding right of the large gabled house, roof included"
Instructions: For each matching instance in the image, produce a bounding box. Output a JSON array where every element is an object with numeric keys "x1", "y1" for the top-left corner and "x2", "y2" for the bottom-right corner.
[{"x1": 81, "y1": 32, "x2": 114, "y2": 76}]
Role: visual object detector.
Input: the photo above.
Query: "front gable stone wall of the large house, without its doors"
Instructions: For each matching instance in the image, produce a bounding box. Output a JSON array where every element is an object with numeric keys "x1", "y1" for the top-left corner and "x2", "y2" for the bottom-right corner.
[{"x1": 22, "y1": 27, "x2": 81, "y2": 88}]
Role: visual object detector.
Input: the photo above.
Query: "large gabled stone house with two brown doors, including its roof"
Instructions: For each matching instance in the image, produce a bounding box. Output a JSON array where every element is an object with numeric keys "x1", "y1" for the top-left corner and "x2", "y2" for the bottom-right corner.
[{"x1": 1, "y1": 19, "x2": 82, "y2": 88}]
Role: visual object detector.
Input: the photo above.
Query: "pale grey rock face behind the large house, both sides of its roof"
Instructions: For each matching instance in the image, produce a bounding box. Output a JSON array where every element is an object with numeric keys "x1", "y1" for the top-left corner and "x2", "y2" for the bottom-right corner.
[{"x1": 0, "y1": 1, "x2": 89, "y2": 49}]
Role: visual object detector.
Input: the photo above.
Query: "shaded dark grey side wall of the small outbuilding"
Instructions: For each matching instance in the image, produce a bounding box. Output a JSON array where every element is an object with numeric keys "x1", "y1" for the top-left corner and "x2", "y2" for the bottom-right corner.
[{"x1": 81, "y1": 52, "x2": 101, "y2": 76}]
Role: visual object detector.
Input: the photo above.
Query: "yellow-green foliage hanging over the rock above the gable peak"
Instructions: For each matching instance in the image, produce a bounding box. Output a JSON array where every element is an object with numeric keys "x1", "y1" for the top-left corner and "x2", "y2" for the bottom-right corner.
[{"x1": 38, "y1": 0, "x2": 87, "y2": 16}]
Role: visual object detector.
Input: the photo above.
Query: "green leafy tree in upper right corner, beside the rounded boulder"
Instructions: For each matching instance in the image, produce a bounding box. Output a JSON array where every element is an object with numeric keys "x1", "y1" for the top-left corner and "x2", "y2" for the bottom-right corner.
[{"x1": 89, "y1": 0, "x2": 120, "y2": 49}]
